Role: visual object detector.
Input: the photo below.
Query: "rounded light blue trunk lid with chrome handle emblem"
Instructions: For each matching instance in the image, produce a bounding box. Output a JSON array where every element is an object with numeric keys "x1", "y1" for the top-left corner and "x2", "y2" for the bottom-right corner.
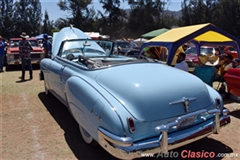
[{"x1": 96, "y1": 63, "x2": 212, "y2": 121}]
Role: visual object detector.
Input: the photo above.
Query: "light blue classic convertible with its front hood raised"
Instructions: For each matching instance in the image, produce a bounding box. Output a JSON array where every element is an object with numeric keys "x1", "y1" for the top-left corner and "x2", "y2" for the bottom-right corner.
[{"x1": 40, "y1": 27, "x2": 230, "y2": 159}]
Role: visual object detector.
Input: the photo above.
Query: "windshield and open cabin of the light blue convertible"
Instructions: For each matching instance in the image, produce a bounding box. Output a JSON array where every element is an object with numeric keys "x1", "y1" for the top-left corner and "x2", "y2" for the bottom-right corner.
[{"x1": 57, "y1": 39, "x2": 156, "y2": 70}]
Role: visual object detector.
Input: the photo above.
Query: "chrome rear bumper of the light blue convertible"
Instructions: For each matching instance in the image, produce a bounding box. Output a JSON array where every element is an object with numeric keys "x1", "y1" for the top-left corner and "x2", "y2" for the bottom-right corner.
[{"x1": 98, "y1": 109, "x2": 230, "y2": 159}]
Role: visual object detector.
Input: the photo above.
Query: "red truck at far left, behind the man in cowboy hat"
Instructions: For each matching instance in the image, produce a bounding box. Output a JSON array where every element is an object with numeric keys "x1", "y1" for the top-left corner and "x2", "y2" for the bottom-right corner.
[{"x1": 7, "y1": 38, "x2": 44, "y2": 65}]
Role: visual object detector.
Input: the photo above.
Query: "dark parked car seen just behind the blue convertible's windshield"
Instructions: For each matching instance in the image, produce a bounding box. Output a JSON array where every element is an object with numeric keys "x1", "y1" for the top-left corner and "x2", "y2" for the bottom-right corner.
[{"x1": 113, "y1": 41, "x2": 140, "y2": 57}]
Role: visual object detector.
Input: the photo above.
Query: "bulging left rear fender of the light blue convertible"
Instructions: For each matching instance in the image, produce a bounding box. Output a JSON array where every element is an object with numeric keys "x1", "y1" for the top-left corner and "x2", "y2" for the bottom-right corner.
[{"x1": 65, "y1": 76, "x2": 123, "y2": 141}]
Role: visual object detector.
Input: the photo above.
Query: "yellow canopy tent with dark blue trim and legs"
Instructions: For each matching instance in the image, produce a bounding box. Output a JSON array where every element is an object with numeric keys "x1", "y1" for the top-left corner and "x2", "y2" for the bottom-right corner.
[{"x1": 140, "y1": 23, "x2": 240, "y2": 65}]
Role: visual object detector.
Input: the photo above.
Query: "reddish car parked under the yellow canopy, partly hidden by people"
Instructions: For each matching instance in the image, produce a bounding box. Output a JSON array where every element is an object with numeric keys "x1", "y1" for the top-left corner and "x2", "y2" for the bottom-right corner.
[{"x1": 185, "y1": 46, "x2": 223, "y2": 67}]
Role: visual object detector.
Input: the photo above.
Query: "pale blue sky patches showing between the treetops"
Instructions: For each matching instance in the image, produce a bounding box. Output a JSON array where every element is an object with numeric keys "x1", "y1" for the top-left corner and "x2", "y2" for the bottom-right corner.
[{"x1": 40, "y1": 0, "x2": 182, "y2": 21}]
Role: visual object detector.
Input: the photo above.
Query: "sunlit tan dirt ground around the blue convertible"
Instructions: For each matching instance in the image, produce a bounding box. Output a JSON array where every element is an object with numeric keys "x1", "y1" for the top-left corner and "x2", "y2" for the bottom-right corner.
[{"x1": 0, "y1": 66, "x2": 240, "y2": 160}]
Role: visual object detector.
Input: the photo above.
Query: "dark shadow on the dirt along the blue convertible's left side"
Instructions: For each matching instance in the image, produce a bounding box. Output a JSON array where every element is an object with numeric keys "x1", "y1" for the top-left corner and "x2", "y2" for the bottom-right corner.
[{"x1": 38, "y1": 92, "x2": 116, "y2": 160}]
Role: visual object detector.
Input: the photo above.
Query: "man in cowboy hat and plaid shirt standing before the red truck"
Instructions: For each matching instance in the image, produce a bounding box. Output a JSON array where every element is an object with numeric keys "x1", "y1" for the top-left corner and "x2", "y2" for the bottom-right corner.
[{"x1": 19, "y1": 32, "x2": 33, "y2": 81}]
